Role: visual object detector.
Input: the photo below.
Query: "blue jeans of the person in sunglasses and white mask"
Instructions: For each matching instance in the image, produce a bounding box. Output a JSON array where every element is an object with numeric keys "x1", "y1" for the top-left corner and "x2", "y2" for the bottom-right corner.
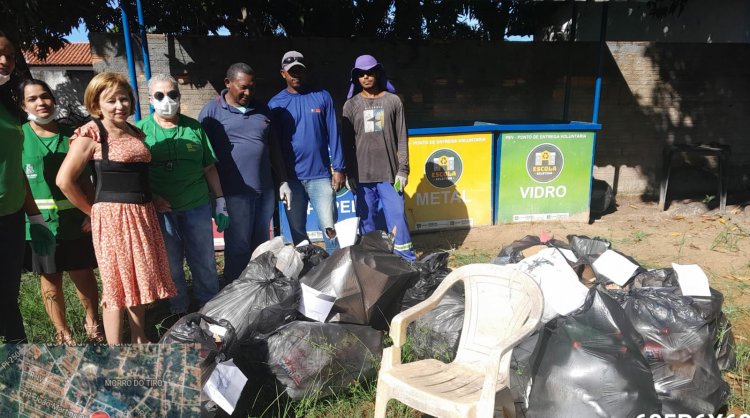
[{"x1": 159, "y1": 203, "x2": 219, "y2": 312}]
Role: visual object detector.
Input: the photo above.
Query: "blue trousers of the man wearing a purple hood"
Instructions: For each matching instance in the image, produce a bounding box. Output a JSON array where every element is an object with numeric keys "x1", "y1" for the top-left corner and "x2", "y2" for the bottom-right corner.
[{"x1": 357, "y1": 181, "x2": 417, "y2": 261}]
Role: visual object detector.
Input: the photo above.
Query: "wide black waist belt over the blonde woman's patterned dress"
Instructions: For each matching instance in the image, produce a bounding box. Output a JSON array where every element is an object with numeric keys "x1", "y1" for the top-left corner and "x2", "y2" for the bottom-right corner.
[{"x1": 94, "y1": 160, "x2": 151, "y2": 203}]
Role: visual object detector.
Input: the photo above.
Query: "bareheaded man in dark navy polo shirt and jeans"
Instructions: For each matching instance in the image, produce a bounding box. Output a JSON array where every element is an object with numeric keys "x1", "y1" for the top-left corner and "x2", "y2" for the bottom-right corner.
[{"x1": 198, "y1": 62, "x2": 292, "y2": 284}]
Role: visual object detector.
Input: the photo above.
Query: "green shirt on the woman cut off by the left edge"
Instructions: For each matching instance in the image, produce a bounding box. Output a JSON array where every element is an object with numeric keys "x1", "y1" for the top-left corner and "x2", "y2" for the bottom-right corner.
[{"x1": 0, "y1": 104, "x2": 26, "y2": 216}]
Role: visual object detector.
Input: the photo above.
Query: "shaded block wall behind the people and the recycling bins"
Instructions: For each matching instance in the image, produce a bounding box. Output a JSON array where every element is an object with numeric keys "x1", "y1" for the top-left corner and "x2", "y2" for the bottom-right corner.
[{"x1": 91, "y1": 35, "x2": 750, "y2": 199}]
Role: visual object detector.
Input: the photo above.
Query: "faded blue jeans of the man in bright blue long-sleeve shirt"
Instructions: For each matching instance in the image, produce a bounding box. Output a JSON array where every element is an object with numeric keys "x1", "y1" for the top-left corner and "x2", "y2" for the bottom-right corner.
[{"x1": 286, "y1": 178, "x2": 338, "y2": 253}]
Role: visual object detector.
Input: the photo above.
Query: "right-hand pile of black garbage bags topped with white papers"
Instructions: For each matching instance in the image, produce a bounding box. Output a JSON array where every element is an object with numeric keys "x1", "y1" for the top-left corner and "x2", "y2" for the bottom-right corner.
[{"x1": 494, "y1": 235, "x2": 736, "y2": 417}]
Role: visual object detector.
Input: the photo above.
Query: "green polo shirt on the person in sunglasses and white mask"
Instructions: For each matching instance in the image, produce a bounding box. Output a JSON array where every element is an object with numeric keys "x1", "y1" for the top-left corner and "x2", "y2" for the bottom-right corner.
[{"x1": 137, "y1": 115, "x2": 216, "y2": 210}]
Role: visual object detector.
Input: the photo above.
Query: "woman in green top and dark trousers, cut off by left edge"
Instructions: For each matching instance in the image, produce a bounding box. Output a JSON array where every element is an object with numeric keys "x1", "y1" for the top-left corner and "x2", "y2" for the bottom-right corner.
[{"x1": 0, "y1": 32, "x2": 54, "y2": 343}]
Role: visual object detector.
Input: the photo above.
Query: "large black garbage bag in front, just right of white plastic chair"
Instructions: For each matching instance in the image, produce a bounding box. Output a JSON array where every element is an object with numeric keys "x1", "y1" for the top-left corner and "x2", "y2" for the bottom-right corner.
[{"x1": 526, "y1": 289, "x2": 661, "y2": 418}]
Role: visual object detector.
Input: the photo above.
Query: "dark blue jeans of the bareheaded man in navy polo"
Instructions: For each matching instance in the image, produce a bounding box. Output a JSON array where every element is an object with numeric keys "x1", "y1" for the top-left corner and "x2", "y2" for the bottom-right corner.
[{"x1": 224, "y1": 189, "x2": 276, "y2": 285}]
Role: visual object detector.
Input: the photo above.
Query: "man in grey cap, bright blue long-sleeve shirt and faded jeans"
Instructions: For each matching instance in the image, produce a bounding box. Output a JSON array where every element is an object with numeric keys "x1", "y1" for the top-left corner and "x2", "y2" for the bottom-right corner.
[{"x1": 268, "y1": 51, "x2": 346, "y2": 252}]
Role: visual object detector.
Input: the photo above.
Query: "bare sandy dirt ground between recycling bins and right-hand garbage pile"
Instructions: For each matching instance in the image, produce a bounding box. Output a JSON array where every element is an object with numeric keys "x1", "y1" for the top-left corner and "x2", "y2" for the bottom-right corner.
[{"x1": 413, "y1": 196, "x2": 750, "y2": 342}]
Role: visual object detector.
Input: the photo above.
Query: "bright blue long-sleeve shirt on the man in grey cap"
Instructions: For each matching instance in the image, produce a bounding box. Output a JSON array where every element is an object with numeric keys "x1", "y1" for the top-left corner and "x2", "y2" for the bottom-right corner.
[{"x1": 268, "y1": 89, "x2": 346, "y2": 180}]
